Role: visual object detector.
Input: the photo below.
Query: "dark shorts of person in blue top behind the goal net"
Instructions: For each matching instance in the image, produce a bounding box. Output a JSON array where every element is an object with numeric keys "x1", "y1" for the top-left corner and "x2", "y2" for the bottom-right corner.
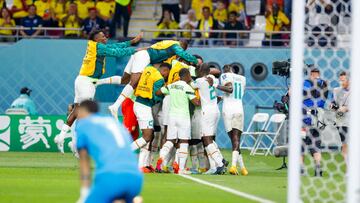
[{"x1": 301, "y1": 128, "x2": 321, "y2": 154}]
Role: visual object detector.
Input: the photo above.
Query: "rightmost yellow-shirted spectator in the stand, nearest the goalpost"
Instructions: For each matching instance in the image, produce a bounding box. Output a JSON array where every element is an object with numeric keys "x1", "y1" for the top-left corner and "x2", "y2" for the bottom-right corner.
[{"x1": 263, "y1": 4, "x2": 290, "y2": 46}]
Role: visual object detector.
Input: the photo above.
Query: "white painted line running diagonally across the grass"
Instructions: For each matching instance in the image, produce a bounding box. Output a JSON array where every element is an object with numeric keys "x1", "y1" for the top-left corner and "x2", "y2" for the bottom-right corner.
[{"x1": 179, "y1": 175, "x2": 273, "y2": 203}]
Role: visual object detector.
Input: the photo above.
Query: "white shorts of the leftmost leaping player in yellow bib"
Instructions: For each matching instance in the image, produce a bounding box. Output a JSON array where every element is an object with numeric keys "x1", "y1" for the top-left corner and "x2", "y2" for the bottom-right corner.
[{"x1": 74, "y1": 75, "x2": 96, "y2": 103}]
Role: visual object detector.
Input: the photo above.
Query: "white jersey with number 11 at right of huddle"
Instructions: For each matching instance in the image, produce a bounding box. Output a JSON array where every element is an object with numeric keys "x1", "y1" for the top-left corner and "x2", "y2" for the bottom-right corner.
[{"x1": 220, "y1": 73, "x2": 246, "y2": 113}]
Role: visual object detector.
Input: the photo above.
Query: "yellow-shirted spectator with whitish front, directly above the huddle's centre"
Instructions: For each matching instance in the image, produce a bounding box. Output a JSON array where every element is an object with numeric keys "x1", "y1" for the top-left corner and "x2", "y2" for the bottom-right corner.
[{"x1": 197, "y1": 7, "x2": 219, "y2": 45}]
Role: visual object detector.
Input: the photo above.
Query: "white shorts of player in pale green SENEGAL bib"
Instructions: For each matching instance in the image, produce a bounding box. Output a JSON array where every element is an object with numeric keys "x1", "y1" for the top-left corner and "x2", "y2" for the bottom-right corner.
[{"x1": 166, "y1": 116, "x2": 191, "y2": 140}]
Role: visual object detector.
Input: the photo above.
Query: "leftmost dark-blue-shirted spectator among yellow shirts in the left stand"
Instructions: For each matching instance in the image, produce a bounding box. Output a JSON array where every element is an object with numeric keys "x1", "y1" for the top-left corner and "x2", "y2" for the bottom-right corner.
[{"x1": 20, "y1": 5, "x2": 42, "y2": 37}]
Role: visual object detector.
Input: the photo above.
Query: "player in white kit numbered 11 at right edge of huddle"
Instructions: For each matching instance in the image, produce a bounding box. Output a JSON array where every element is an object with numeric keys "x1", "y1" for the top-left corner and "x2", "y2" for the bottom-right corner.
[{"x1": 217, "y1": 65, "x2": 248, "y2": 176}]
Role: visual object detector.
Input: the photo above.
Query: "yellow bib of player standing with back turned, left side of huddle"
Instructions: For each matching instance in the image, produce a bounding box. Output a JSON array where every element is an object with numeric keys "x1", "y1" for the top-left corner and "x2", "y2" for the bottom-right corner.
[{"x1": 135, "y1": 66, "x2": 163, "y2": 99}]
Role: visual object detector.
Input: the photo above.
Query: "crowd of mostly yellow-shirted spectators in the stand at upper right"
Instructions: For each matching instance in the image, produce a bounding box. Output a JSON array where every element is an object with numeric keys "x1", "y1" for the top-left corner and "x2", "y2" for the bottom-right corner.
[{"x1": 154, "y1": 0, "x2": 291, "y2": 46}]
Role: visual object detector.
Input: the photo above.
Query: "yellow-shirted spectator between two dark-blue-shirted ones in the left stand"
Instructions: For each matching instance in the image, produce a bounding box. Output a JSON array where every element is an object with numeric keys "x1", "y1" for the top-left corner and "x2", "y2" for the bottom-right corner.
[{"x1": 61, "y1": 3, "x2": 81, "y2": 38}]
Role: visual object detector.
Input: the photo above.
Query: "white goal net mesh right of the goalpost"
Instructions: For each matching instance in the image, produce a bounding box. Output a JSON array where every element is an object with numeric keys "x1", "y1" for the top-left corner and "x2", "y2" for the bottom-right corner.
[{"x1": 301, "y1": 0, "x2": 351, "y2": 202}]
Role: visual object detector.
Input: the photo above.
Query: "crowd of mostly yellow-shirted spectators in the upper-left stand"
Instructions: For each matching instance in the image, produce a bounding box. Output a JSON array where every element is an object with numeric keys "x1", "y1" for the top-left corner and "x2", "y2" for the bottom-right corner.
[{"x1": 0, "y1": 0, "x2": 131, "y2": 41}]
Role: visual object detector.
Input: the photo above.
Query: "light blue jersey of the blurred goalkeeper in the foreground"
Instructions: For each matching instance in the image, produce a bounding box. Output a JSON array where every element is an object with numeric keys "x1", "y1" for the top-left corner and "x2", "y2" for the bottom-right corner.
[{"x1": 75, "y1": 114, "x2": 140, "y2": 175}]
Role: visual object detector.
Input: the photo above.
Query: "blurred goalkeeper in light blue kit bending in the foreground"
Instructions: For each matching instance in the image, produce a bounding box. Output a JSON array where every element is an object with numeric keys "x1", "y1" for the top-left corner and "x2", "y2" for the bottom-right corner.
[{"x1": 75, "y1": 100, "x2": 143, "y2": 203}]
